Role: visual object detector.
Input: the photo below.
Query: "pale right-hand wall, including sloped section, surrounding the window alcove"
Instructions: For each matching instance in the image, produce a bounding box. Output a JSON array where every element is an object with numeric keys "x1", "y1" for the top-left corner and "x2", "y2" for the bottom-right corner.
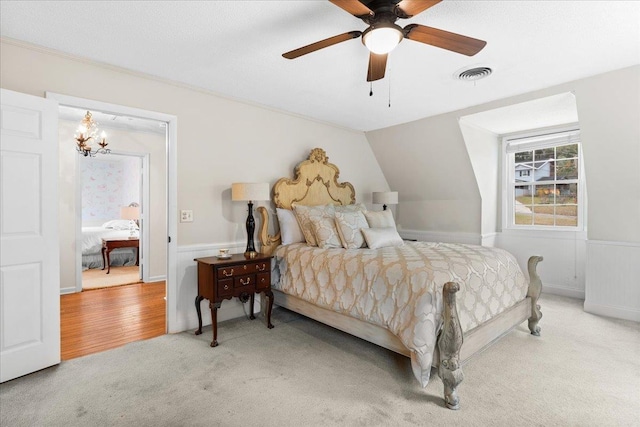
[{"x1": 366, "y1": 66, "x2": 640, "y2": 320}]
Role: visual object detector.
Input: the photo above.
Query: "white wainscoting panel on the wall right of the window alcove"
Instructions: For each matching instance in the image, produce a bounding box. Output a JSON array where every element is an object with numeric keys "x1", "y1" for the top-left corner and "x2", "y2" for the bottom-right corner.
[{"x1": 584, "y1": 240, "x2": 640, "y2": 322}]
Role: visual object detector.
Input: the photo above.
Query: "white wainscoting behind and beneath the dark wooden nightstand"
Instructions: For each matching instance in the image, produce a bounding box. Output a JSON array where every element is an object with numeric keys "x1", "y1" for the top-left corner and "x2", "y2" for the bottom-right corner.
[{"x1": 178, "y1": 242, "x2": 255, "y2": 333}]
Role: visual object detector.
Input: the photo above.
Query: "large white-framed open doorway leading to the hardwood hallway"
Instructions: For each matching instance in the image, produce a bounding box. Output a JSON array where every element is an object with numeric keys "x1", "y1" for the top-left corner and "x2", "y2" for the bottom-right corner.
[{"x1": 47, "y1": 93, "x2": 177, "y2": 359}]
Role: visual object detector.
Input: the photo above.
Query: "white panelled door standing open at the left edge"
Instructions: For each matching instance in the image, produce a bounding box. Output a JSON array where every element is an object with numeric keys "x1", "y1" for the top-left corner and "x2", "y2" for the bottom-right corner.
[{"x1": 0, "y1": 89, "x2": 60, "y2": 382}]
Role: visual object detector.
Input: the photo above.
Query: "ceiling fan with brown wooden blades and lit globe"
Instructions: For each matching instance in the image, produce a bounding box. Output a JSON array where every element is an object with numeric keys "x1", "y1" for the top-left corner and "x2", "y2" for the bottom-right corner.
[{"x1": 282, "y1": 0, "x2": 487, "y2": 82}]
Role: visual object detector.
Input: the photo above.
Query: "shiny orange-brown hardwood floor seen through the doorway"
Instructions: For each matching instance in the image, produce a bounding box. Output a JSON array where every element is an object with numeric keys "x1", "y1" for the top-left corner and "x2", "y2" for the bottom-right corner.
[{"x1": 60, "y1": 282, "x2": 166, "y2": 360}]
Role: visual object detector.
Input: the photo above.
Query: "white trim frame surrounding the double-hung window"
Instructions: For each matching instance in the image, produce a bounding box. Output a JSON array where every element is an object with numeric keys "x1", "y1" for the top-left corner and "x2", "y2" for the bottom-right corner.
[{"x1": 501, "y1": 123, "x2": 587, "y2": 232}]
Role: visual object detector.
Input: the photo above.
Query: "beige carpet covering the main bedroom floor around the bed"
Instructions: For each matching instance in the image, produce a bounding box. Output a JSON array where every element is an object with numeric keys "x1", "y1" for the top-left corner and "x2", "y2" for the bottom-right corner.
[{"x1": 0, "y1": 296, "x2": 640, "y2": 427}]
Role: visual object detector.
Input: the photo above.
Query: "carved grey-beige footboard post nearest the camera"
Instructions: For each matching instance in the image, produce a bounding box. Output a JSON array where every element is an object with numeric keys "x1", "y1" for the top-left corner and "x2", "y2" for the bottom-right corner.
[{"x1": 438, "y1": 282, "x2": 464, "y2": 409}]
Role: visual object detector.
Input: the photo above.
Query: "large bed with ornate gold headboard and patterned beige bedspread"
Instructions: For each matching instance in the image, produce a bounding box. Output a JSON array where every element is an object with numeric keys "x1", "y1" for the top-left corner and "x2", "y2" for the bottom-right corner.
[{"x1": 258, "y1": 148, "x2": 542, "y2": 409}]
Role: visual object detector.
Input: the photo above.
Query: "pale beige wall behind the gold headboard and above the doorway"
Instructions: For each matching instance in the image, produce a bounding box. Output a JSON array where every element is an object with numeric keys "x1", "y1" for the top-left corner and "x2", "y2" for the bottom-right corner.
[{"x1": 0, "y1": 40, "x2": 389, "y2": 332}]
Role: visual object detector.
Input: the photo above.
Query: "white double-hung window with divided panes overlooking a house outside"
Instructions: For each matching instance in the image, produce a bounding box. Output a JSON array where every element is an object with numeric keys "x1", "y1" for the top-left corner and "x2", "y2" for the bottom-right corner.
[{"x1": 503, "y1": 129, "x2": 584, "y2": 229}]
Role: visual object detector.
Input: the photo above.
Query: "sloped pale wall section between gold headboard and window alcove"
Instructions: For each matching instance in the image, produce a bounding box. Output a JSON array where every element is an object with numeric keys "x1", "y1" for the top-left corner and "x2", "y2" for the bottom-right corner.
[{"x1": 366, "y1": 116, "x2": 481, "y2": 233}]
